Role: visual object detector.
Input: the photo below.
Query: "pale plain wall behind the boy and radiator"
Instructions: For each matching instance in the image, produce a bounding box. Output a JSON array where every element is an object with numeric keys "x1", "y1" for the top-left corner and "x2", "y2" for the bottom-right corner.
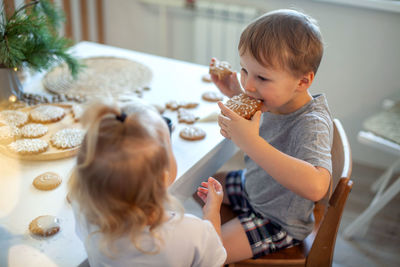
[{"x1": 105, "y1": 0, "x2": 400, "y2": 166}]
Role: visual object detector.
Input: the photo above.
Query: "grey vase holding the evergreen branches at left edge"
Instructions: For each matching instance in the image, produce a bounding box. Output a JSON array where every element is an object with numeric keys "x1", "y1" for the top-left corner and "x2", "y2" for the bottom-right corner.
[{"x1": 0, "y1": 66, "x2": 24, "y2": 102}]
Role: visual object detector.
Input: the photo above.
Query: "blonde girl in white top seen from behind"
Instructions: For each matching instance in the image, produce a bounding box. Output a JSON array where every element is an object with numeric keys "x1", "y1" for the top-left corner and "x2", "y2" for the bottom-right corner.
[{"x1": 69, "y1": 102, "x2": 226, "y2": 267}]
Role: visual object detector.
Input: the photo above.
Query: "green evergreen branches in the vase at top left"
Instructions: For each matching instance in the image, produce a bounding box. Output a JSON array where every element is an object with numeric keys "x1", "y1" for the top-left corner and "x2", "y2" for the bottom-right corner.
[{"x1": 0, "y1": 0, "x2": 82, "y2": 77}]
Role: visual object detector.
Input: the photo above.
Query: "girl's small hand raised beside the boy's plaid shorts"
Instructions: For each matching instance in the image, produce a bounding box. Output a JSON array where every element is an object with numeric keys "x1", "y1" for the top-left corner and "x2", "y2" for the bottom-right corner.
[{"x1": 197, "y1": 177, "x2": 224, "y2": 217}]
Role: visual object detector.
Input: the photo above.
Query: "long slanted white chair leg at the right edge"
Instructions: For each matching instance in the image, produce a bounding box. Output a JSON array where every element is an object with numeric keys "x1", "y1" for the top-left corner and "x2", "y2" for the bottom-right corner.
[{"x1": 343, "y1": 176, "x2": 400, "y2": 239}]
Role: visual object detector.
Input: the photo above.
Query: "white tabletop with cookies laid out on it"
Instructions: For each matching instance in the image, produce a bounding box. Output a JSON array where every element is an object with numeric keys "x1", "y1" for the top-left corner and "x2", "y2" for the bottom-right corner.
[{"x1": 0, "y1": 42, "x2": 237, "y2": 267}]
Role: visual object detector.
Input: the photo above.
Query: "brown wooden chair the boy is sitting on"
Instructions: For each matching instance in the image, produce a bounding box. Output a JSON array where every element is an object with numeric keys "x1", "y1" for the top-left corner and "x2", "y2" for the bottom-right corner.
[{"x1": 228, "y1": 119, "x2": 353, "y2": 267}]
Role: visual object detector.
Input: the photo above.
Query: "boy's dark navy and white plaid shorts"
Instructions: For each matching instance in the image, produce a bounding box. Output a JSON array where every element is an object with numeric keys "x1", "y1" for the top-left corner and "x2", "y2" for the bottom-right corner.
[{"x1": 225, "y1": 170, "x2": 299, "y2": 259}]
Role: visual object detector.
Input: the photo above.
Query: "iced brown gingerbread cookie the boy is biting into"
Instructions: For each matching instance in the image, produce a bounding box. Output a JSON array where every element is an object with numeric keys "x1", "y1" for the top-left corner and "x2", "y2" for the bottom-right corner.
[{"x1": 225, "y1": 93, "x2": 262, "y2": 120}]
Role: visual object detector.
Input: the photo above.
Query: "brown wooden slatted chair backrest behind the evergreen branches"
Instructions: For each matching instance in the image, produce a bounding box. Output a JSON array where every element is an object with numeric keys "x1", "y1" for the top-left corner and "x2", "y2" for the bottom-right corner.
[{"x1": 3, "y1": 0, "x2": 105, "y2": 43}]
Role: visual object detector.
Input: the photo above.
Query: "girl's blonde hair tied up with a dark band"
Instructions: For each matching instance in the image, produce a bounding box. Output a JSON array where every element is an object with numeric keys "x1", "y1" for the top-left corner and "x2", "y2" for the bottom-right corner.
[{"x1": 69, "y1": 103, "x2": 182, "y2": 253}]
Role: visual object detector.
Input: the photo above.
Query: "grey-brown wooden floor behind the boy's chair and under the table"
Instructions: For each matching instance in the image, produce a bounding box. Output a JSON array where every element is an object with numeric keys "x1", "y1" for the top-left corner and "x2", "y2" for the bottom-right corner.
[{"x1": 185, "y1": 154, "x2": 400, "y2": 267}]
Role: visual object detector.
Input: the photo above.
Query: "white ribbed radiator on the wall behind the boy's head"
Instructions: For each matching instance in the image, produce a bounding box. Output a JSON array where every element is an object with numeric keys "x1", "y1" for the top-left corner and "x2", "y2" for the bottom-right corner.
[{"x1": 193, "y1": 1, "x2": 258, "y2": 70}]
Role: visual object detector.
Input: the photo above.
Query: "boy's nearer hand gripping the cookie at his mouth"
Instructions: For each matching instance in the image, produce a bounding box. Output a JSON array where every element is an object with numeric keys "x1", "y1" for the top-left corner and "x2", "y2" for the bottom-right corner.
[{"x1": 218, "y1": 101, "x2": 261, "y2": 148}]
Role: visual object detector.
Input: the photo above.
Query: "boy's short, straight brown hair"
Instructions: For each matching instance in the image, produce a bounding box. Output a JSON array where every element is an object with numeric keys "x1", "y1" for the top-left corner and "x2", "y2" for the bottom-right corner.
[{"x1": 238, "y1": 9, "x2": 323, "y2": 77}]
